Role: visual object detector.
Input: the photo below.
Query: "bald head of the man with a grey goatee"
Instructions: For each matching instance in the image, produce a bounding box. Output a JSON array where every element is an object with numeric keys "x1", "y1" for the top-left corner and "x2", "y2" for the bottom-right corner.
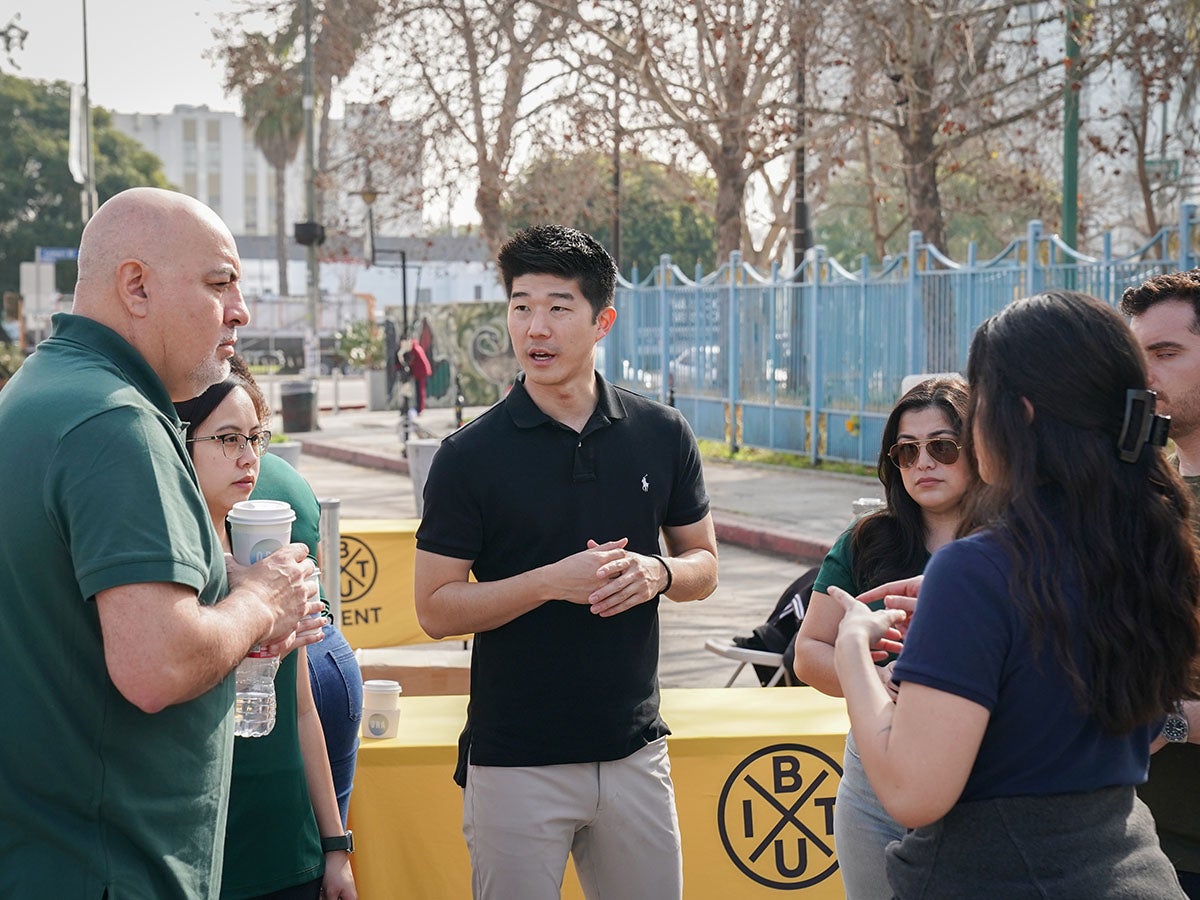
[{"x1": 73, "y1": 187, "x2": 250, "y2": 401}]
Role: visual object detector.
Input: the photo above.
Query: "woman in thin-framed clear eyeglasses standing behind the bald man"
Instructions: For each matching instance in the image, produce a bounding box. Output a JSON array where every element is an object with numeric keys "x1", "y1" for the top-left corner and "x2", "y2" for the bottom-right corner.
[{"x1": 175, "y1": 373, "x2": 358, "y2": 900}]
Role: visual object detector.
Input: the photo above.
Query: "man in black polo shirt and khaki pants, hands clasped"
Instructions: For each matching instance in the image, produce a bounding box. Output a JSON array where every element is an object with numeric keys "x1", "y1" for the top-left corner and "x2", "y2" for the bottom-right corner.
[{"x1": 415, "y1": 226, "x2": 716, "y2": 900}]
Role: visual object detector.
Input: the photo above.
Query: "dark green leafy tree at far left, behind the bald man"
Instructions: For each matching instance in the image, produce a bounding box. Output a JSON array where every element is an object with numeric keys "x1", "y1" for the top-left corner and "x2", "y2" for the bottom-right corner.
[{"x1": 0, "y1": 73, "x2": 169, "y2": 292}]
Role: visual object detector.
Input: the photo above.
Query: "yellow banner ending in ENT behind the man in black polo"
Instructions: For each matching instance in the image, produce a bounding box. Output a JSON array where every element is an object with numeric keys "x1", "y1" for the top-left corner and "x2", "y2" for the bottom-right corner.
[{"x1": 340, "y1": 518, "x2": 468, "y2": 649}]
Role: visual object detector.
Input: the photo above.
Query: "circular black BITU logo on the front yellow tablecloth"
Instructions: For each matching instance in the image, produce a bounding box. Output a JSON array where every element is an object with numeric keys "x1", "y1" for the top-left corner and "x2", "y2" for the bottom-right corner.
[{"x1": 716, "y1": 744, "x2": 841, "y2": 890}]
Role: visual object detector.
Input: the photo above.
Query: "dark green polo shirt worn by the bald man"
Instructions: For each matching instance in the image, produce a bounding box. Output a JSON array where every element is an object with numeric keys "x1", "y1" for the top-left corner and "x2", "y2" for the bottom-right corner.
[{"x1": 0, "y1": 314, "x2": 233, "y2": 900}]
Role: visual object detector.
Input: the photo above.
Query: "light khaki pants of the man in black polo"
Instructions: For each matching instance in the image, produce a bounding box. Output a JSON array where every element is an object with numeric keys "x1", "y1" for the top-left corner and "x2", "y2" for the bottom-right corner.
[{"x1": 462, "y1": 738, "x2": 683, "y2": 900}]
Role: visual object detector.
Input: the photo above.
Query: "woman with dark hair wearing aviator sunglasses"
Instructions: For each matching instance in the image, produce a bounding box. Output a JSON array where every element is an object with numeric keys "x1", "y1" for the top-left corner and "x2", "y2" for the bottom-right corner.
[{"x1": 794, "y1": 378, "x2": 977, "y2": 900}]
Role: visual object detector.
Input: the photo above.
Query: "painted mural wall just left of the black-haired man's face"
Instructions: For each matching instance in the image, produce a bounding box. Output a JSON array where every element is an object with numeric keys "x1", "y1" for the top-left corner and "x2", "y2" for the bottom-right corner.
[{"x1": 386, "y1": 302, "x2": 520, "y2": 407}]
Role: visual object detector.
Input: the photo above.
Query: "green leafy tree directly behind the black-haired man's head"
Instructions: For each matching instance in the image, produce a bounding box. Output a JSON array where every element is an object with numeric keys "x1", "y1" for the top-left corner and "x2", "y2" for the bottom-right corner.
[{"x1": 503, "y1": 152, "x2": 716, "y2": 276}]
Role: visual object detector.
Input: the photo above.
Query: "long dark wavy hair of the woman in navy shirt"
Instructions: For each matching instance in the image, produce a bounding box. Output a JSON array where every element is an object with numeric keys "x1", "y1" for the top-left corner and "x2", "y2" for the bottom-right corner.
[{"x1": 967, "y1": 290, "x2": 1200, "y2": 733}]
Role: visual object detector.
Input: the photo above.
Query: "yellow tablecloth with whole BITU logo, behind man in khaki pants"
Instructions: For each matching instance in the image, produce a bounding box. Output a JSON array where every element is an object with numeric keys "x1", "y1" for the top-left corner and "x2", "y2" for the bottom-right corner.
[{"x1": 350, "y1": 688, "x2": 850, "y2": 900}]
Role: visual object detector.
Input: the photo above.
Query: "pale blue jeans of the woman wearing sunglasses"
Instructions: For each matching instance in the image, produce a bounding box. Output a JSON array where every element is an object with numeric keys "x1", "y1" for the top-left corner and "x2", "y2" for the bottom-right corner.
[{"x1": 833, "y1": 733, "x2": 907, "y2": 900}]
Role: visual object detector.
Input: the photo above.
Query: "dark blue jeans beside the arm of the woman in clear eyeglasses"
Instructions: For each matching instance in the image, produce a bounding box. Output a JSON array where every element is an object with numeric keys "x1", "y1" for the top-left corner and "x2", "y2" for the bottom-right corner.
[{"x1": 308, "y1": 625, "x2": 362, "y2": 828}]
